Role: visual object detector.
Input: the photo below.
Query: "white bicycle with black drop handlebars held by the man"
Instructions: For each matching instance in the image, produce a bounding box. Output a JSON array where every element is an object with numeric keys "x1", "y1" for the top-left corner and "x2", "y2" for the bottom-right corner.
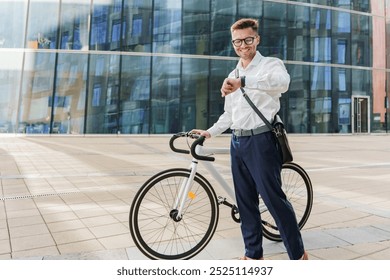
[{"x1": 129, "y1": 132, "x2": 313, "y2": 260}]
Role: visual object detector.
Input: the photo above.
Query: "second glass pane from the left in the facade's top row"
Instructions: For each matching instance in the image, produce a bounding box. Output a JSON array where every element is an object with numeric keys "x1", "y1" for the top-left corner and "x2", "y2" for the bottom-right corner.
[{"x1": 26, "y1": 0, "x2": 60, "y2": 49}]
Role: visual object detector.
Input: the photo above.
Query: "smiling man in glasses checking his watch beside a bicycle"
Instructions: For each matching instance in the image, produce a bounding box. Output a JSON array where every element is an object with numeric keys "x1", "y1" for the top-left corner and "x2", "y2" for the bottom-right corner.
[{"x1": 192, "y1": 19, "x2": 308, "y2": 260}]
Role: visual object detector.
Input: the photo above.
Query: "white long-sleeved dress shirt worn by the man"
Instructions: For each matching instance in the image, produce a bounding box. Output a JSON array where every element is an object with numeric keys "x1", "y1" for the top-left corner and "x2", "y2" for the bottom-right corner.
[{"x1": 207, "y1": 51, "x2": 290, "y2": 136}]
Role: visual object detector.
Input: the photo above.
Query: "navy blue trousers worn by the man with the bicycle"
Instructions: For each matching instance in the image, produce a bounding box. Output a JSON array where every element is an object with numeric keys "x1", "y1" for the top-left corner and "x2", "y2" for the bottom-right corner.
[{"x1": 231, "y1": 131, "x2": 304, "y2": 259}]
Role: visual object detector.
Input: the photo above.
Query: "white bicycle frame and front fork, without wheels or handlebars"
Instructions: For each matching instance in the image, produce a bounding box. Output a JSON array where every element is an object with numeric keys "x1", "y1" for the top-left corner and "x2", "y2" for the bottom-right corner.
[{"x1": 173, "y1": 145, "x2": 236, "y2": 218}]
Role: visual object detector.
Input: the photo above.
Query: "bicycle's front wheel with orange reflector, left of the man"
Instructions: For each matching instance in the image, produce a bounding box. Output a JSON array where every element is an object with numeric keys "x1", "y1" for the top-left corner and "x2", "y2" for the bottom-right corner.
[{"x1": 129, "y1": 169, "x2": 219, "y2": 260}]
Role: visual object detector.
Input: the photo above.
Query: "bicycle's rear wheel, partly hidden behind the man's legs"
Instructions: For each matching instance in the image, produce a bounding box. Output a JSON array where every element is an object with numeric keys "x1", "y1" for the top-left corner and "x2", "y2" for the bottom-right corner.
[{"x1": 260, "y1": 162, "x2": 313, "y2": 241}]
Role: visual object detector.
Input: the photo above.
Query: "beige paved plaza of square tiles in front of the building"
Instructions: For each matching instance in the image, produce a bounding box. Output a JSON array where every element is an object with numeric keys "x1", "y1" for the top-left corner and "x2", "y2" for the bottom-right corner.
[{"x1": 0, "y1": 134, "x2": 390, "y2": 260}]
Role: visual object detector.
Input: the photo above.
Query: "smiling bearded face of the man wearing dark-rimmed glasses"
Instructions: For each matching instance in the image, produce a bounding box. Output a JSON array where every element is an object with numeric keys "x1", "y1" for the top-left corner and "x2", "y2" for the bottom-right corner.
[{"x1": 232, "y1": 27, "x2": 260, "y2": 60}]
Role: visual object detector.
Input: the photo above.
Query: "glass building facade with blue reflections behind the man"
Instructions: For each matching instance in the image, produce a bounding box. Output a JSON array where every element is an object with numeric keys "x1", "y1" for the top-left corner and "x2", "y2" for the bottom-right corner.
[{"x1": 0, "y1": 0, "x2": 390, "y2": 134}]
